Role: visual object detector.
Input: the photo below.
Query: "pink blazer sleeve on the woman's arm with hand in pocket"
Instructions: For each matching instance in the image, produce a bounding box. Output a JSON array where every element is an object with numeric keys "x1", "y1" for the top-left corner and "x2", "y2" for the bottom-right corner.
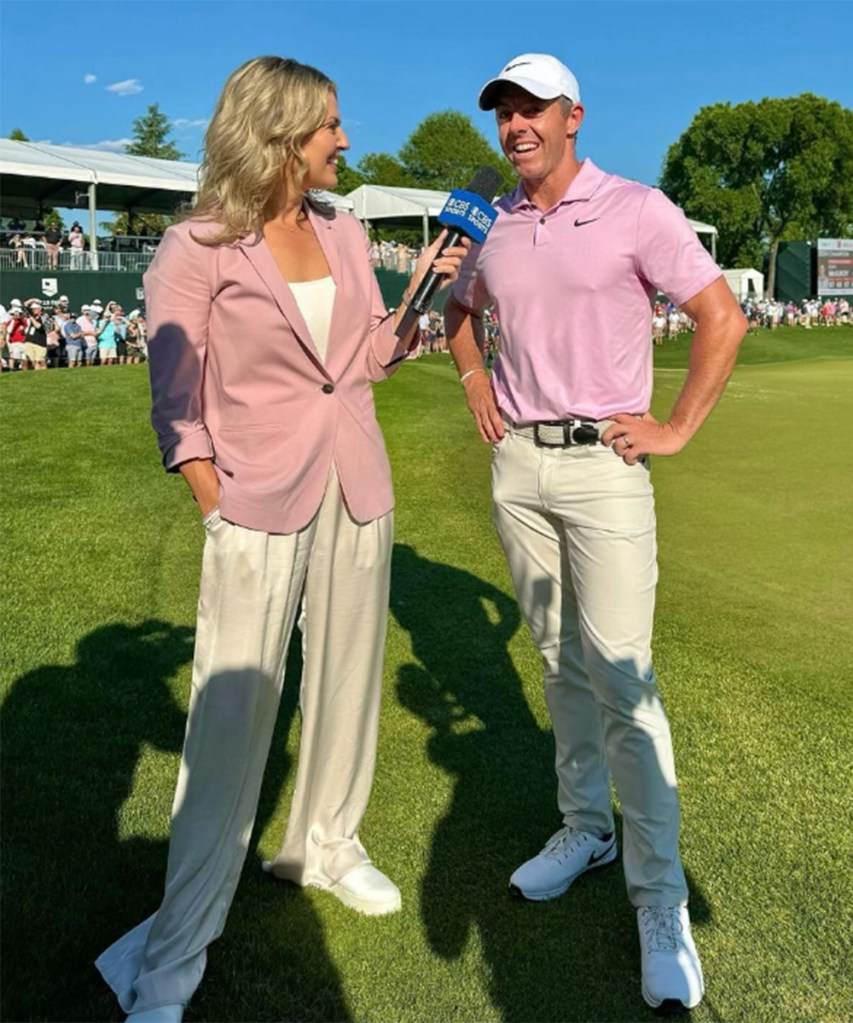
[{"x1": 144, "y1": 223, "x2": 214, "y2": 472}]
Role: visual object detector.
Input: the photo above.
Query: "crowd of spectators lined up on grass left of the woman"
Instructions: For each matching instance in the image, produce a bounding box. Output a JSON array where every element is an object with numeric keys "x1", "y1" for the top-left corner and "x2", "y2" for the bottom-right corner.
[{"x1": 0, "y1": 295, "x2": 148, "y2": 372}]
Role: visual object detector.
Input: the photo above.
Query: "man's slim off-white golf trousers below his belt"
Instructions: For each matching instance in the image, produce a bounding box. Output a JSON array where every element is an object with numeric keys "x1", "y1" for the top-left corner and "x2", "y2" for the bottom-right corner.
[{"x1": 492, "y1": 431, "x2": 687, "y2": 906}]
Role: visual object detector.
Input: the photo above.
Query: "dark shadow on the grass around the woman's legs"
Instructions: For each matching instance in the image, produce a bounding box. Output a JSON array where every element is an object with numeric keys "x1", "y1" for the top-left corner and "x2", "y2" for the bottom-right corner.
[{"x1": 0, "y1": 620, "x2": 350, "y2": 1020}]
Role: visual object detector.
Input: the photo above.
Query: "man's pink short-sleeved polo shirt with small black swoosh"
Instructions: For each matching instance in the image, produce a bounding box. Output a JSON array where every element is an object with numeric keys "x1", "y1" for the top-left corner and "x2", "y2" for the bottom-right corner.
[{"x1": 453, "y1": 160, "x2": 721, "y2": 424}]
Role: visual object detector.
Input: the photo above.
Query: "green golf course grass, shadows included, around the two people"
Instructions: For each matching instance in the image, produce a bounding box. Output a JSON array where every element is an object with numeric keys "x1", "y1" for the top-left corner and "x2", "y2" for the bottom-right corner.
[{"x1": 0, "y1": 327, "x2": 853, "y2": 1023}]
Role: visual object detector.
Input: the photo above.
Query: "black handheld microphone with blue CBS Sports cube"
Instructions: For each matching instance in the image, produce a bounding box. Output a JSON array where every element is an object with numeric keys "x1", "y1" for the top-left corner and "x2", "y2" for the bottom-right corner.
[{"x1": 394, "y1": 167, "x2": 500, "y2": 338}]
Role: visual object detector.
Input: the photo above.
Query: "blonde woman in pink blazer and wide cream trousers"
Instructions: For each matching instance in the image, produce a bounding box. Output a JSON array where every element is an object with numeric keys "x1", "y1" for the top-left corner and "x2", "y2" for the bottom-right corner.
[{"x1": 97, "y1": 57, "x2": 465, "y2": 1023}]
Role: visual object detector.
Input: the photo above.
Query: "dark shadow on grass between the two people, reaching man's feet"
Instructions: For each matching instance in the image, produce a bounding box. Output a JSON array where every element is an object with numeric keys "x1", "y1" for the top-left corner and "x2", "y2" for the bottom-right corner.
[{"x1": 391, "y1": 545, "x2": 710, "y2": 1021}]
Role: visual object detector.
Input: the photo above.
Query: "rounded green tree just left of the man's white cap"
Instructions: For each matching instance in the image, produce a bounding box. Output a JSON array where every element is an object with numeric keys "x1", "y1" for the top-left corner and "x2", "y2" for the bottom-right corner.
[{"x1": 400, "y1": 110, "x2": 515, "y2": 197}]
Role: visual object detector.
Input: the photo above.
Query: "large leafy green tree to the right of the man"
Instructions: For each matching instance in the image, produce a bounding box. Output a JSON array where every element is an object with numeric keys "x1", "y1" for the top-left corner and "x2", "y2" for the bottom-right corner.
[{"x1": 661, "y1": 93, "x2": 853, "y2": 295}]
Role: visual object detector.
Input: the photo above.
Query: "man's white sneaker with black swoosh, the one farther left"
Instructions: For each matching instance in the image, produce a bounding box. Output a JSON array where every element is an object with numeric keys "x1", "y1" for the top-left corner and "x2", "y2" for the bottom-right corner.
[{"x1": 509, "y1": 826, "x2": 616, "y2": 902}]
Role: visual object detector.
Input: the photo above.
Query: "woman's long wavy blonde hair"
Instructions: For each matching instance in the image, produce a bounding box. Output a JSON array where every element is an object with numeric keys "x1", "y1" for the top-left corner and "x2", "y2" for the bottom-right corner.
[{"x1": 186, "y1": 56, "x2": 336, "y2": 246}]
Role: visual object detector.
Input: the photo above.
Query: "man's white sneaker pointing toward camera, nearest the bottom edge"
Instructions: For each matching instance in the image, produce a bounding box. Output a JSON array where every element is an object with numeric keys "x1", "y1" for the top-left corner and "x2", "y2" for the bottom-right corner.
[{"x1": 637, "y1": 905, "x2": 705, "y2": 1009}]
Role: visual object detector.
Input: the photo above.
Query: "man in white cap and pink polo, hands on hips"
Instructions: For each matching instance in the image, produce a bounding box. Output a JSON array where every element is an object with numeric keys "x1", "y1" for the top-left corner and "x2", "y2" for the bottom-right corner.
[{"x1": 445, "y1": 53, "x2": 746, "y2": 1008}]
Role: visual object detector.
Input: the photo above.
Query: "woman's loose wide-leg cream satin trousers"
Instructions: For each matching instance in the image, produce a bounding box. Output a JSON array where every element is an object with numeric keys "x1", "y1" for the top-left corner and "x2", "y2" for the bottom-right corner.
[{"x1": 96, "y1": 471, "x2": 394, "y2": 1012}]
